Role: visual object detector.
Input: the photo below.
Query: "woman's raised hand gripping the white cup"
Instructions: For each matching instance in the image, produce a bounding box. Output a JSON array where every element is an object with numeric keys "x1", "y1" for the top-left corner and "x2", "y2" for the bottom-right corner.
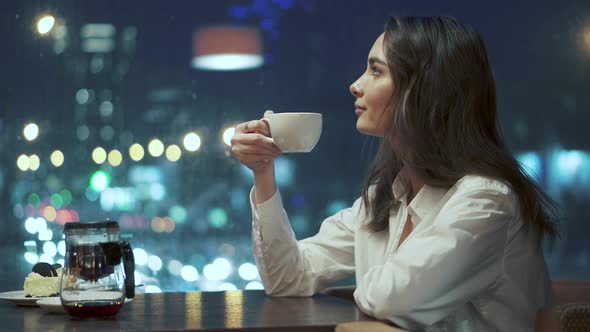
[{"x1": 231, "y1": 111, "x2": 281, "y2": 177}]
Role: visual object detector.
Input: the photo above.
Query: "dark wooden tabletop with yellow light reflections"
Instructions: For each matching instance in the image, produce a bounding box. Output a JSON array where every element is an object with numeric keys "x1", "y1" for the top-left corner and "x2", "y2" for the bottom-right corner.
[{"x1": 0, "y1": 290, "x2": 374, "y2": 331}]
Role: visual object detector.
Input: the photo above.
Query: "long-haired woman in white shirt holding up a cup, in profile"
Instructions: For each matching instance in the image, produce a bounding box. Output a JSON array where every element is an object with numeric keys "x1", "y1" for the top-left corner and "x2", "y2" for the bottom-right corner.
[{"x1": 232, "y1": 17, "x2": 555, "y2": 331}]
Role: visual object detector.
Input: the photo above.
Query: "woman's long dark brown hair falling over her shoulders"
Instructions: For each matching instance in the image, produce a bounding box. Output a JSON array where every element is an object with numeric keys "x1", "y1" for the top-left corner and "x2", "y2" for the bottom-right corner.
[{"x1": 363, "y1": 17, "x2": 556, "y2": 244}]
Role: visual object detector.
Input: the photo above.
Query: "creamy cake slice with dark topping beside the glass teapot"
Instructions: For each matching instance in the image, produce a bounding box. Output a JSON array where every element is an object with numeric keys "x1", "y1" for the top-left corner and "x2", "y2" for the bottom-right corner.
[{"x1": 23, "y1": 263, "x2": 62, "y2": 297}]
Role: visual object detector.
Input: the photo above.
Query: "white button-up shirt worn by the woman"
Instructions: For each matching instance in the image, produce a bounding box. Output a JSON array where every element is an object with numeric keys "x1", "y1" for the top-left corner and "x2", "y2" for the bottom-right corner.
[{"x1": 250, "y1": 173, "x2": 553, "y2": 331}]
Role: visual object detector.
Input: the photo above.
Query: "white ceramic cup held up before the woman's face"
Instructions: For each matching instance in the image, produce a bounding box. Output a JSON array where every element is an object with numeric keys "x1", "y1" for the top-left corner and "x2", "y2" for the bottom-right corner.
[{"x1": 264, "y1": 112, "x2": 322, "y2": 153}]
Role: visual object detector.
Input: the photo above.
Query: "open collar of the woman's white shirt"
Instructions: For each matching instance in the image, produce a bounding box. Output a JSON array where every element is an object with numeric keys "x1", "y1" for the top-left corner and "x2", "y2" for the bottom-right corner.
[{"x1": 392, "y1": 167, "x2": 448, "y2": 225}]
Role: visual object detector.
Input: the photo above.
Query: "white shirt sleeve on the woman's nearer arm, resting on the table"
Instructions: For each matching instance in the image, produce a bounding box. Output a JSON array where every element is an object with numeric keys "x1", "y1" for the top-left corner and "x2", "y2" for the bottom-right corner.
[{"x1": 354, "y1": 187, "x2": 515, "y2": 330}]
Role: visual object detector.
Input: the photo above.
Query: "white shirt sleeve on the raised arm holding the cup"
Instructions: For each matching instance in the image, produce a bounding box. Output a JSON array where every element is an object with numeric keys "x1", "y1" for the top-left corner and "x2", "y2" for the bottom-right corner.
[{"x1": 250, "y1": 185, "x2": 360, "y2": 296}]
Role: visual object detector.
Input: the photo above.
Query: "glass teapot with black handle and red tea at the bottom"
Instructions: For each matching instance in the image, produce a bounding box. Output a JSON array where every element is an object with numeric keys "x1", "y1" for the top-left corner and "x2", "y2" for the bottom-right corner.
[{"x1": 59, "y1": 220, "x2": 135, "y2": 317}]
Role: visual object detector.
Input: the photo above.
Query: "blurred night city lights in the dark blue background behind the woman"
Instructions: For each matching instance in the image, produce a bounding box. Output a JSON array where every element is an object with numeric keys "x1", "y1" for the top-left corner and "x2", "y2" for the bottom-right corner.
[{"x1": 0, "y1": 0, "x2": 590, "y2": 292}]
